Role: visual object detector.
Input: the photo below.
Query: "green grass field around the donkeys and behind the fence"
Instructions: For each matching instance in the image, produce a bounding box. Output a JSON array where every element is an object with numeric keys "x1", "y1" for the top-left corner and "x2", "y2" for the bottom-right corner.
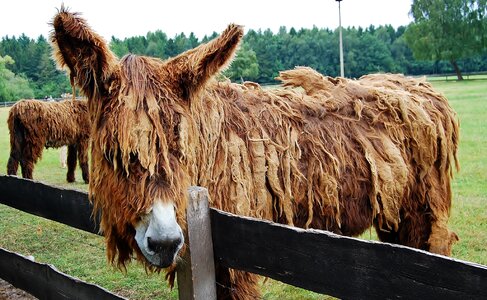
[{"x1": 0, "y1": 79, "x2": 487, "y2": 299}]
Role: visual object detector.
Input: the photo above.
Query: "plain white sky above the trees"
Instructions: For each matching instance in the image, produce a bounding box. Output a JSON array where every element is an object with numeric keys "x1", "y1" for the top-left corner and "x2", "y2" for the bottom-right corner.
[{"x1": 0, "y1": 0, "x2": 412, "y2": 40}]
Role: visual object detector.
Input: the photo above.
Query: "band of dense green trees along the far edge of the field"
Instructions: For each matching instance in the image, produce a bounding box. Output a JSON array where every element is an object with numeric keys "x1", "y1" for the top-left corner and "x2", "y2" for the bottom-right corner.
[{"x1": 0, "y1": 0, "x2": 487, "y2": 101}]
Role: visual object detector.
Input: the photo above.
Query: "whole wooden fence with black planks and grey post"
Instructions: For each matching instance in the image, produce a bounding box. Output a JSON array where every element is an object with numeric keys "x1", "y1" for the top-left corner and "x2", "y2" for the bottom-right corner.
[{"x1": 0, "y1": 176, "x2": 487, "y2": 299}]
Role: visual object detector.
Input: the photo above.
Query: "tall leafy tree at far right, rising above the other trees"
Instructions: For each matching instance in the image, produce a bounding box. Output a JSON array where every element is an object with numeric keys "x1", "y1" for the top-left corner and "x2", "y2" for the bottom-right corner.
[{"x1": 405, "y1": 0, "x2": 487, "y2": 80}]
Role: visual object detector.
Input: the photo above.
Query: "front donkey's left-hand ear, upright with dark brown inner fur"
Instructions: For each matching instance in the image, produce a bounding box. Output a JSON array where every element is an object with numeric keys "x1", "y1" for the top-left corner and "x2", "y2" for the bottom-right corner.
[{"x1": 50, "y1": 6, "x2": 117, "y2": 99}]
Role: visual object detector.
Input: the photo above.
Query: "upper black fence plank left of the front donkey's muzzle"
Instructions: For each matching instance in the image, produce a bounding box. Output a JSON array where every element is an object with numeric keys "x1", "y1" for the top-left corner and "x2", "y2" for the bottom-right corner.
[{"x1": 0, "y1": 175, "x2": 99, "y2": 234}]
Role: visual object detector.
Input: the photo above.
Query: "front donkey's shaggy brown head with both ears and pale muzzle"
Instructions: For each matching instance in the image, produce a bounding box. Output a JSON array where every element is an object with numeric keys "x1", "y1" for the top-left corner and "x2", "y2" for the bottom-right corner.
[{"x1": 51, "y1": 8, "x2": 243, "y2": 268}]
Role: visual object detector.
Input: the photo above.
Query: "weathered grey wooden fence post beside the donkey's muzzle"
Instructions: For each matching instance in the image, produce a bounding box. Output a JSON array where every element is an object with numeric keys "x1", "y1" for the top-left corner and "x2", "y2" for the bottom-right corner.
[{"x1": 177, "y1": 186, "x2": 216, "y2": 300}]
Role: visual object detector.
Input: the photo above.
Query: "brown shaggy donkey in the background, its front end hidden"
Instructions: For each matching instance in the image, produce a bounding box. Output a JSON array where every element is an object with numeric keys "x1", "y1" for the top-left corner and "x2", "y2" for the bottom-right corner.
[{"x1": 7, "y1": 100, "x2": 90, "y2": 183}]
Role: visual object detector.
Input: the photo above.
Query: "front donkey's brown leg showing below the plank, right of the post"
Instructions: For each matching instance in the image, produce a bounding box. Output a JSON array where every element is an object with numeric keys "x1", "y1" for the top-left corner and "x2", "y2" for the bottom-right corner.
[{"x1": 215, "y1": 264, "x2": 261, "y2": 300}]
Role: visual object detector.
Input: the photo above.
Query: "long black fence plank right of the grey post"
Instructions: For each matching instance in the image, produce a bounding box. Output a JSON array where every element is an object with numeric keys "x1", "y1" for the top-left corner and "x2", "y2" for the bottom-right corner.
[{"x1": 211, "y1": 209, "x2": 487, "y2": 299}]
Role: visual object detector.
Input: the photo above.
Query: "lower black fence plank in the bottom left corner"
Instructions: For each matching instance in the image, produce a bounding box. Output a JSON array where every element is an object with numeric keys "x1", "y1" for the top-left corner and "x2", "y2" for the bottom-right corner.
[{"x1": 0, "y1": 248, "x2": 125, "y2": 300}]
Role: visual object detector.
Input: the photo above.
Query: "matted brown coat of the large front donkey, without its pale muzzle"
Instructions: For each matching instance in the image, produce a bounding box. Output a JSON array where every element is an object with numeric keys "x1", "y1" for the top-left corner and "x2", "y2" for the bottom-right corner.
[{"x1": 51, "y1": 9, "x2": 458, "y2": 299}]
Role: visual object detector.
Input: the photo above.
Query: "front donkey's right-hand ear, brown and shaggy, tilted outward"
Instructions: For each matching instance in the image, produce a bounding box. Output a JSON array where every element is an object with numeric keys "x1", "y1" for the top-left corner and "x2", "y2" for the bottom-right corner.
[{"x1": 167, "y1": 24, "x2": 243, "y2": 100}]
